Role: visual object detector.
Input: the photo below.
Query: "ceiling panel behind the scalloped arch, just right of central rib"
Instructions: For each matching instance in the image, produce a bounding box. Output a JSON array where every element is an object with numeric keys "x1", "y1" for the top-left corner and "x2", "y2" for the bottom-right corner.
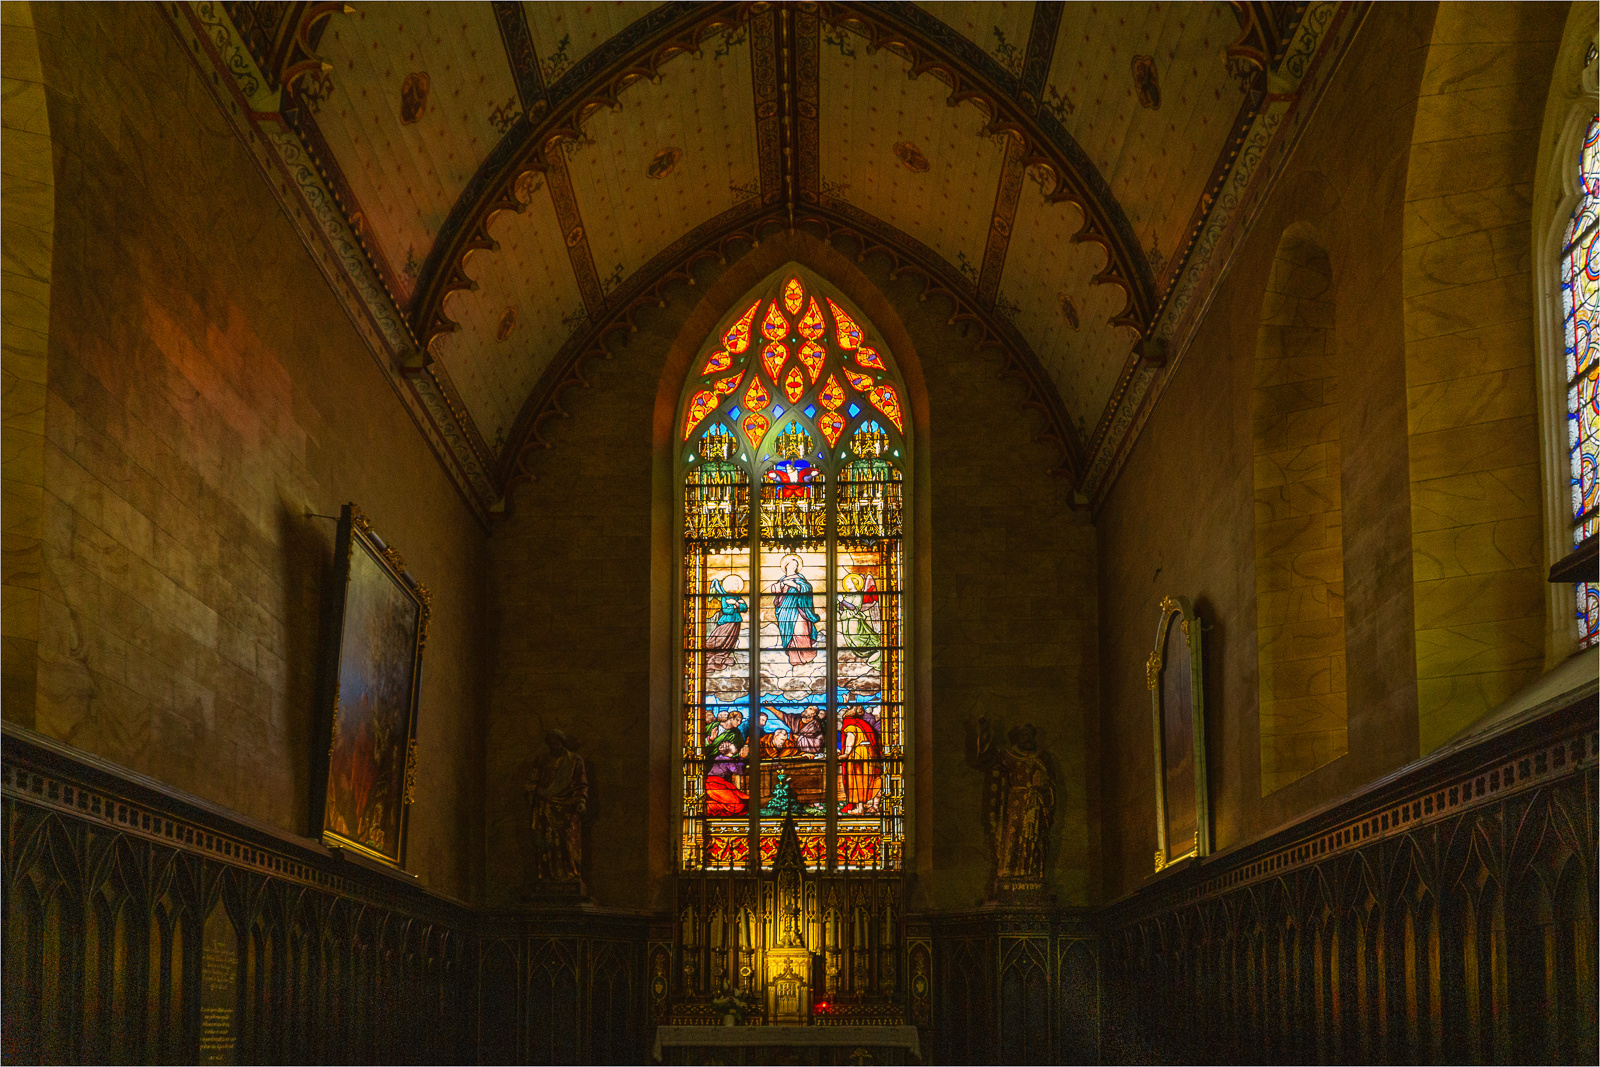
[{"x1": 819, "y1": 30, "x2": 1005, "y2": 285}]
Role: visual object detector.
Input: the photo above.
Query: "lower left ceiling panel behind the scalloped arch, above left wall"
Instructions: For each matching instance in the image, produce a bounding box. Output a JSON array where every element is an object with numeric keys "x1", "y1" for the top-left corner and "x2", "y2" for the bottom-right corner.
[{"x1": 434, "y1": 174, "x2": 586, "y2": 450}]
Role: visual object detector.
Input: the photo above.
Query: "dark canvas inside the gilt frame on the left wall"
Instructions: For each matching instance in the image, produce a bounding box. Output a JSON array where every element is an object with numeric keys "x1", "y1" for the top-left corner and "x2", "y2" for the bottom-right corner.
[{"x1": 322, "y1": 511, "x2": 424, "y2": 864}]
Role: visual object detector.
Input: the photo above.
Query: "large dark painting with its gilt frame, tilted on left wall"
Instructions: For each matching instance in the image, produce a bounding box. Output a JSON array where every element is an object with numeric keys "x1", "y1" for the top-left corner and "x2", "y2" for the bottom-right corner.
[{"x1": 312, "y1": 504, "x2": 430, "y2": 867}]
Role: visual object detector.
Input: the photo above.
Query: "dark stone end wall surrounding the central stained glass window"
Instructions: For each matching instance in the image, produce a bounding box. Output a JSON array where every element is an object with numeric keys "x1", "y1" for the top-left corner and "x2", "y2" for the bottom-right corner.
[{"x1": 486, "y1": 234, "x2": 1096, "y2": 907}]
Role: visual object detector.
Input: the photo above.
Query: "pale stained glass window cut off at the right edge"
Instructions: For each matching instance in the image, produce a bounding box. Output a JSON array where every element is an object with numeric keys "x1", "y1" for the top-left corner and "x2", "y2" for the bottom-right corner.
[{"x1": 1562, "y1": 117, "x2": 1600, "y2": 648}]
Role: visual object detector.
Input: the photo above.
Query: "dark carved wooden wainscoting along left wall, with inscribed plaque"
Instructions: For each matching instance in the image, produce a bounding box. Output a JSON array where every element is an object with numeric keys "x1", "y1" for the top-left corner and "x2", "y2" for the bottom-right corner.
[{"x1": 0, "y1": 725, "x2": 477, "y2": 1064}]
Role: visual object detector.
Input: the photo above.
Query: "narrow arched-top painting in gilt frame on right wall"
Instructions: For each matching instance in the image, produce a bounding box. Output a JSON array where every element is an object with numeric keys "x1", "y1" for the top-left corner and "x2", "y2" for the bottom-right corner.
[{"x1": 1146, "y1": 597, "x2": 1211, "y2": 872}]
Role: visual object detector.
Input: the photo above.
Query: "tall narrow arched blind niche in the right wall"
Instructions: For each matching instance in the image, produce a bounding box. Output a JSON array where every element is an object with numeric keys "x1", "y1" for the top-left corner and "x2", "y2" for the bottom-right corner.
[{"x1": 1250, "y1": 224, "x2": 1349, "y2": 797}]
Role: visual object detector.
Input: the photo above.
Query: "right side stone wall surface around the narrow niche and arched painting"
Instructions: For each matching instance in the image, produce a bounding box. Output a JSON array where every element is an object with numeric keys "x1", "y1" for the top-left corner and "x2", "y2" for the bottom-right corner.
[{"x1": 1096, "y1": 5, "x2": 1434, "y2": 899}]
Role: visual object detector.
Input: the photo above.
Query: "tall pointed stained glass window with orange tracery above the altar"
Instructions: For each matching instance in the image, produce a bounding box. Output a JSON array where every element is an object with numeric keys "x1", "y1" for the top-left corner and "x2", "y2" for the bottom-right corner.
[{"x1": 677, "y1": 269, "x2": 907, "y2": 870}]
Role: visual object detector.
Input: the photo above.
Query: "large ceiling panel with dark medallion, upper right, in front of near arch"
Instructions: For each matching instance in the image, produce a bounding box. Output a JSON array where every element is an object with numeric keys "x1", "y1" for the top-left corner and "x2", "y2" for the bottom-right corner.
[{"x1": 1043, "y1": 3, "x2": 1243, "y2": 277}]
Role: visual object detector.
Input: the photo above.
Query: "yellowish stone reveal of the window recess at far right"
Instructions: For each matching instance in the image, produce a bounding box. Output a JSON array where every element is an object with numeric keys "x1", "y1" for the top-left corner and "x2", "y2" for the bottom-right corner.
[{"x1": 1405, "y1": 3, "x2": 1568, "y2": 752}]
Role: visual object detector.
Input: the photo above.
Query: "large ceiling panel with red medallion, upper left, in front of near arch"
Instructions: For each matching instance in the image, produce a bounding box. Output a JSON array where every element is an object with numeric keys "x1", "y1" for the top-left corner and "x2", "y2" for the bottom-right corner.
[{"x1": 309, "y1": 3, "x2": 517, "y2": 301}]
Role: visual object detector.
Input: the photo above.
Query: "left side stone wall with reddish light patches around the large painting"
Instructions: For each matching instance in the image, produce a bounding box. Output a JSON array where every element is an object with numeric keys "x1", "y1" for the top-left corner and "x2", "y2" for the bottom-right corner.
[{"x1": 5, "y1": 5, "x2": 485, "y2": 897}]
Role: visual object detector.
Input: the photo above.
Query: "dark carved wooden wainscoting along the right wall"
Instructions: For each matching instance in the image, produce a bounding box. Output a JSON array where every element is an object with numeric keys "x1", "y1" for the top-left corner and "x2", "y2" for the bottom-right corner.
[{"x1": 1101, "y1": 685, "x2": 1600, "y2": 1064}]
